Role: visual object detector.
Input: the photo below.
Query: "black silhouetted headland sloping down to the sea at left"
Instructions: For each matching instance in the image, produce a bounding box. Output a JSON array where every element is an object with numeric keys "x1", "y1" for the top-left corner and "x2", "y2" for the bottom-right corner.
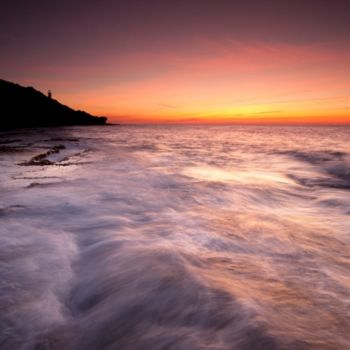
[{"x1": 0, "y1": 79, "x2": 107, "y2": 130}]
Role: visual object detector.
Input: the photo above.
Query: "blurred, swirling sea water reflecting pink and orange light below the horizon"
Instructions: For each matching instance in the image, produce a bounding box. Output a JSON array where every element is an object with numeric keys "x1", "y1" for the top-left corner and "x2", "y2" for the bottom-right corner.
[{"x1": 0, "y1": 126, "x2": 350, "y2": 350}]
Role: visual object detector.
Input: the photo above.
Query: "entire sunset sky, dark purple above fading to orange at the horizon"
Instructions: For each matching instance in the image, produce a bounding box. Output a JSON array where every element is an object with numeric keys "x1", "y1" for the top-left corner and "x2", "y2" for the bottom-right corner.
[{"x1": 0, "y1": 0, "x2": 350, "y2": 124}]
